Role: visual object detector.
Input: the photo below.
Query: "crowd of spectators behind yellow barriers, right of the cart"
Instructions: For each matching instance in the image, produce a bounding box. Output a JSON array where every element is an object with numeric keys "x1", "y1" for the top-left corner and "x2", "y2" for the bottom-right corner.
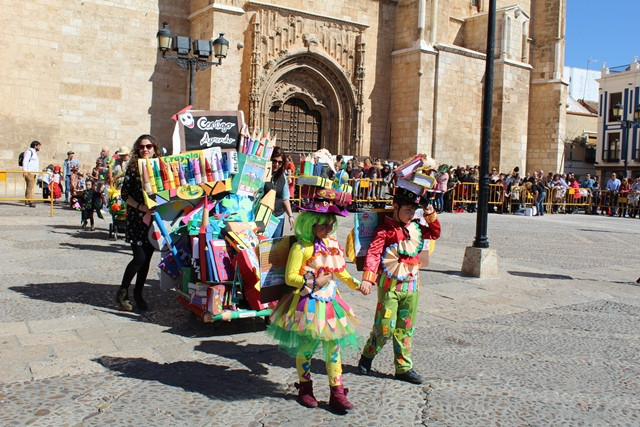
[{"x1": 290, "y1": 155, "x2": 640, "y2": 217}]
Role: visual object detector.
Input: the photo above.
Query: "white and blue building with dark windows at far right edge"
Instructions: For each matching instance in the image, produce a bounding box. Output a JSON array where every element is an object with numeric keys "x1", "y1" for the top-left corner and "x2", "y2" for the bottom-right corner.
[{"x1": 596, "y1": 58, "x2": 640, "y2": 182}]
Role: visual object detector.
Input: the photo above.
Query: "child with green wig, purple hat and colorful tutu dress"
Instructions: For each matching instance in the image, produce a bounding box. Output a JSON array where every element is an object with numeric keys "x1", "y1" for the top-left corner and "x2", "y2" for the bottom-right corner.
[{"x1": 267, "y1": 191, "x2": 368, "y2": 411}]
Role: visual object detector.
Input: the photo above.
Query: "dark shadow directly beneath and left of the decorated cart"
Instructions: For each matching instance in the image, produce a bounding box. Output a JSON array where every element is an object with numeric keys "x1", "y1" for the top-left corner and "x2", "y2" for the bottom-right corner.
[{"x1": 9, "y1": 280, "x2": 266, "y2": 338}]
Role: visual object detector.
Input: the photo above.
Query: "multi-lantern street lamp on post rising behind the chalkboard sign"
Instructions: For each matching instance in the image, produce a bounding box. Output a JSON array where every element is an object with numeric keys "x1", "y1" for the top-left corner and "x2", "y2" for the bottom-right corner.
[{"x1": 156, "y1": 22, "x2": 229, "y2": 105}]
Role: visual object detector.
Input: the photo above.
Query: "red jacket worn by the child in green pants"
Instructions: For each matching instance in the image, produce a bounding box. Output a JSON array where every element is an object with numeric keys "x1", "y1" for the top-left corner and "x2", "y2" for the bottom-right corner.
[{"x1": 362, "y1": 213, "x2": 440, "y2": 283}]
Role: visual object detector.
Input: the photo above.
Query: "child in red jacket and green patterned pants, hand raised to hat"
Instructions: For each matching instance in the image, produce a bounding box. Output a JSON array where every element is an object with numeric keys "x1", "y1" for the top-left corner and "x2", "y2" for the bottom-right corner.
[{"x1": 358, "y1": 188, "x2": 440, "y2": 384}]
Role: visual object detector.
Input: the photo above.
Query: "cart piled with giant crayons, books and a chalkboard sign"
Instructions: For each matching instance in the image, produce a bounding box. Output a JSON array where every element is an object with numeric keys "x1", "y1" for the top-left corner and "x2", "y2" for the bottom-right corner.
[{"x1": 144, "y1": 110, "x2": 293, "y2": 322}]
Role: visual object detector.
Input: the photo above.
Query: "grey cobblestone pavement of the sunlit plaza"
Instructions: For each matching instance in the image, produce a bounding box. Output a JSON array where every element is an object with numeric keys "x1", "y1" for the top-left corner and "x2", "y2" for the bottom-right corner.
[{"x1": 0, "y1": 204, "x2": 640, "y2": 426}]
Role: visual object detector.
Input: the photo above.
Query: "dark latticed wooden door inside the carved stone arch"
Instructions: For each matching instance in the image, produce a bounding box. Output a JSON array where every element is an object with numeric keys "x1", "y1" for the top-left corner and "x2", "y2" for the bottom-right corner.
[{"x1": 269, "y1": 98, "x2": 322, "y2": 153}]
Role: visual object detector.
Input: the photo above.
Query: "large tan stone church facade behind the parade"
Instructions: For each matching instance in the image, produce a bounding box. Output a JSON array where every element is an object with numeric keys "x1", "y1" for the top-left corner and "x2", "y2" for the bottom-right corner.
[{"x1": 0, "y1": 0, "x2": 566, "y2": 176}]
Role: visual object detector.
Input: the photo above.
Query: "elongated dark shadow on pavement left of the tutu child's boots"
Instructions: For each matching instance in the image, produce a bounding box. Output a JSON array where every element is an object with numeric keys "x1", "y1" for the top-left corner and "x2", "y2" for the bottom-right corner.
[{"x1": 93, "y1": 356, "x2": 285, "y2": 400}]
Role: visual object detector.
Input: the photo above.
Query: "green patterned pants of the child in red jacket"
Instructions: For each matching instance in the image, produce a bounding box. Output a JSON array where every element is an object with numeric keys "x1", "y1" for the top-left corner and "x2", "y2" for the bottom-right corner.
[{"x1": 362, "y1": 286, "x2": 419, "y2": 374}]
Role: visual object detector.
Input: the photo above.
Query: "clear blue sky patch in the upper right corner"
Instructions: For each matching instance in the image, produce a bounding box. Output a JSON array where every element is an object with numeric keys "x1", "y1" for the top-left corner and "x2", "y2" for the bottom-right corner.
[{"x1": 564, "y1": 0, "x2": 640, "y2": 70}]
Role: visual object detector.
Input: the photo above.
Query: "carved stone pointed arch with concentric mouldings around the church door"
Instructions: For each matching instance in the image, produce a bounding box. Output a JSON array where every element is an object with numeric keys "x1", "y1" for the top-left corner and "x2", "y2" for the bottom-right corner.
[{"x1": 258, "y1": 50, "x2": 361, "y2": 154}]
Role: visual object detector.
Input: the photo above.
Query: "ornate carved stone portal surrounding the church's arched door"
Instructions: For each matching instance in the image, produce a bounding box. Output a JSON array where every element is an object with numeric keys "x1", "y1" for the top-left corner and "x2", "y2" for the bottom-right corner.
[{"x1": 246, "y1": 2, "x2": 367, "y2": 155}]
